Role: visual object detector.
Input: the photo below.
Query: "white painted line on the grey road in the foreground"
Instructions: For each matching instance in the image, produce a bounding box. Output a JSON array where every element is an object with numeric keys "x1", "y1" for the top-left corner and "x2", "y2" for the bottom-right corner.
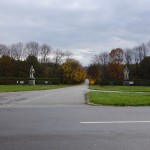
[{"x1": 80, "y1": 121, "x2": 150, "y2": 124}]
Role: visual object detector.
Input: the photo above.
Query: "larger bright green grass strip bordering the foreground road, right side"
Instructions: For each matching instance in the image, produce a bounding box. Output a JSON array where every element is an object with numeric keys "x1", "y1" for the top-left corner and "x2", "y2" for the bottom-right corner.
[{"x1": 88, "y1": 92, "x2": 150, "y2": 106}]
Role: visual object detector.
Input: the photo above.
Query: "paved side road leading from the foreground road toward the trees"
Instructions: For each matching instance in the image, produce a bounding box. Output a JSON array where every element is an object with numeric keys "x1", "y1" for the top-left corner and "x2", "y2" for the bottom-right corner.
[{"x1": 0, "y1": 84, "x2": 88, "y2": 107}]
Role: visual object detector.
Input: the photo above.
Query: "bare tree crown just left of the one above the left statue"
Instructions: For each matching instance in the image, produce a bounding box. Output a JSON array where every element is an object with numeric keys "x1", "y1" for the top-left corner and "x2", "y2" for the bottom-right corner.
[{"x1": 10, "y1": 42, "x2": 24, "y2": 60}]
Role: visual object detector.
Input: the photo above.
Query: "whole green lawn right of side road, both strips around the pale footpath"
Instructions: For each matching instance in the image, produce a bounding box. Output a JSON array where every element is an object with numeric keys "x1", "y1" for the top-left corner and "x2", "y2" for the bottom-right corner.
[{"x1": 88, "y1": 86, "x2": 150, "y2": 106}]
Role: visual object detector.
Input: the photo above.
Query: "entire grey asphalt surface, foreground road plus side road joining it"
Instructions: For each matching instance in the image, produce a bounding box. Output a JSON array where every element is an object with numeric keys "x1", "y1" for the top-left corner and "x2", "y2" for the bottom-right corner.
[{"x1": 0, "y1": 84, "x2": 150, "y2": 150}]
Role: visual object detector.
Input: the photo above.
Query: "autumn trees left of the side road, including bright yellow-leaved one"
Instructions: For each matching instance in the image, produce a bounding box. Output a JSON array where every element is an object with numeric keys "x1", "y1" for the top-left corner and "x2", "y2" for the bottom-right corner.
[{"x1": 0, "y1": 42, "x2": 85, "y2": 84}]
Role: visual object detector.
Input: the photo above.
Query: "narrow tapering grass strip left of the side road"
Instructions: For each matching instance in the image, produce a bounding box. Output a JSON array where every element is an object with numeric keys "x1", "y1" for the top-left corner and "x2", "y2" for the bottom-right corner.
[{"x1": 0, "y1": 85, "x2": 68, "y2": 92}]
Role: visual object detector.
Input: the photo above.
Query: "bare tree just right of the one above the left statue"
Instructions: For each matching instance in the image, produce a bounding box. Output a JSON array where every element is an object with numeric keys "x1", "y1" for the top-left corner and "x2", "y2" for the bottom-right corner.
[{"x1": 40, "y1": 44, "x2": 52, "y2": 63}]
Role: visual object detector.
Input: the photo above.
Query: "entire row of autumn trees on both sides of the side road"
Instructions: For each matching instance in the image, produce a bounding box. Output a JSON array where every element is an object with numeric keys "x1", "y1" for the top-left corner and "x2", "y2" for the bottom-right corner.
[{"x1": 0, "y1": 41, "x2": 150, "y2": 84}]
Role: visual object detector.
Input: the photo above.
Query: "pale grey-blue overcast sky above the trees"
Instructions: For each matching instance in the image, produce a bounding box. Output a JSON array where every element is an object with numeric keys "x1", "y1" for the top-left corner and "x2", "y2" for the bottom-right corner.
[{"x1": 0, "y1": 0, "x2": 150, "y2": 65}]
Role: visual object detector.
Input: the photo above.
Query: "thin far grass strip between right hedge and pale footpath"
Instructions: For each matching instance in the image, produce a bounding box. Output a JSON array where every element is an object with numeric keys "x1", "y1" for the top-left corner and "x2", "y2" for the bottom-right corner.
[{"x1": 90, "y1": 85, "x2": 150, "y2": 92}]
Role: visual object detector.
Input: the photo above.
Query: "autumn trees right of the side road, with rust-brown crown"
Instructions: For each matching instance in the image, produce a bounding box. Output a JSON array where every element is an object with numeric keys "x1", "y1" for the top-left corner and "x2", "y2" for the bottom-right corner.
[{"x1": 87, "y1": 41, "x2": 150, "y2": 84}]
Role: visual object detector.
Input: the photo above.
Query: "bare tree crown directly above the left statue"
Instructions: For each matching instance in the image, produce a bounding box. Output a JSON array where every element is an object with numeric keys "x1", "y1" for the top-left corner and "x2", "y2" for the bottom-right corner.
[{"x1": 25, "y1": 42, "x2": 39, "y2": 57}]
